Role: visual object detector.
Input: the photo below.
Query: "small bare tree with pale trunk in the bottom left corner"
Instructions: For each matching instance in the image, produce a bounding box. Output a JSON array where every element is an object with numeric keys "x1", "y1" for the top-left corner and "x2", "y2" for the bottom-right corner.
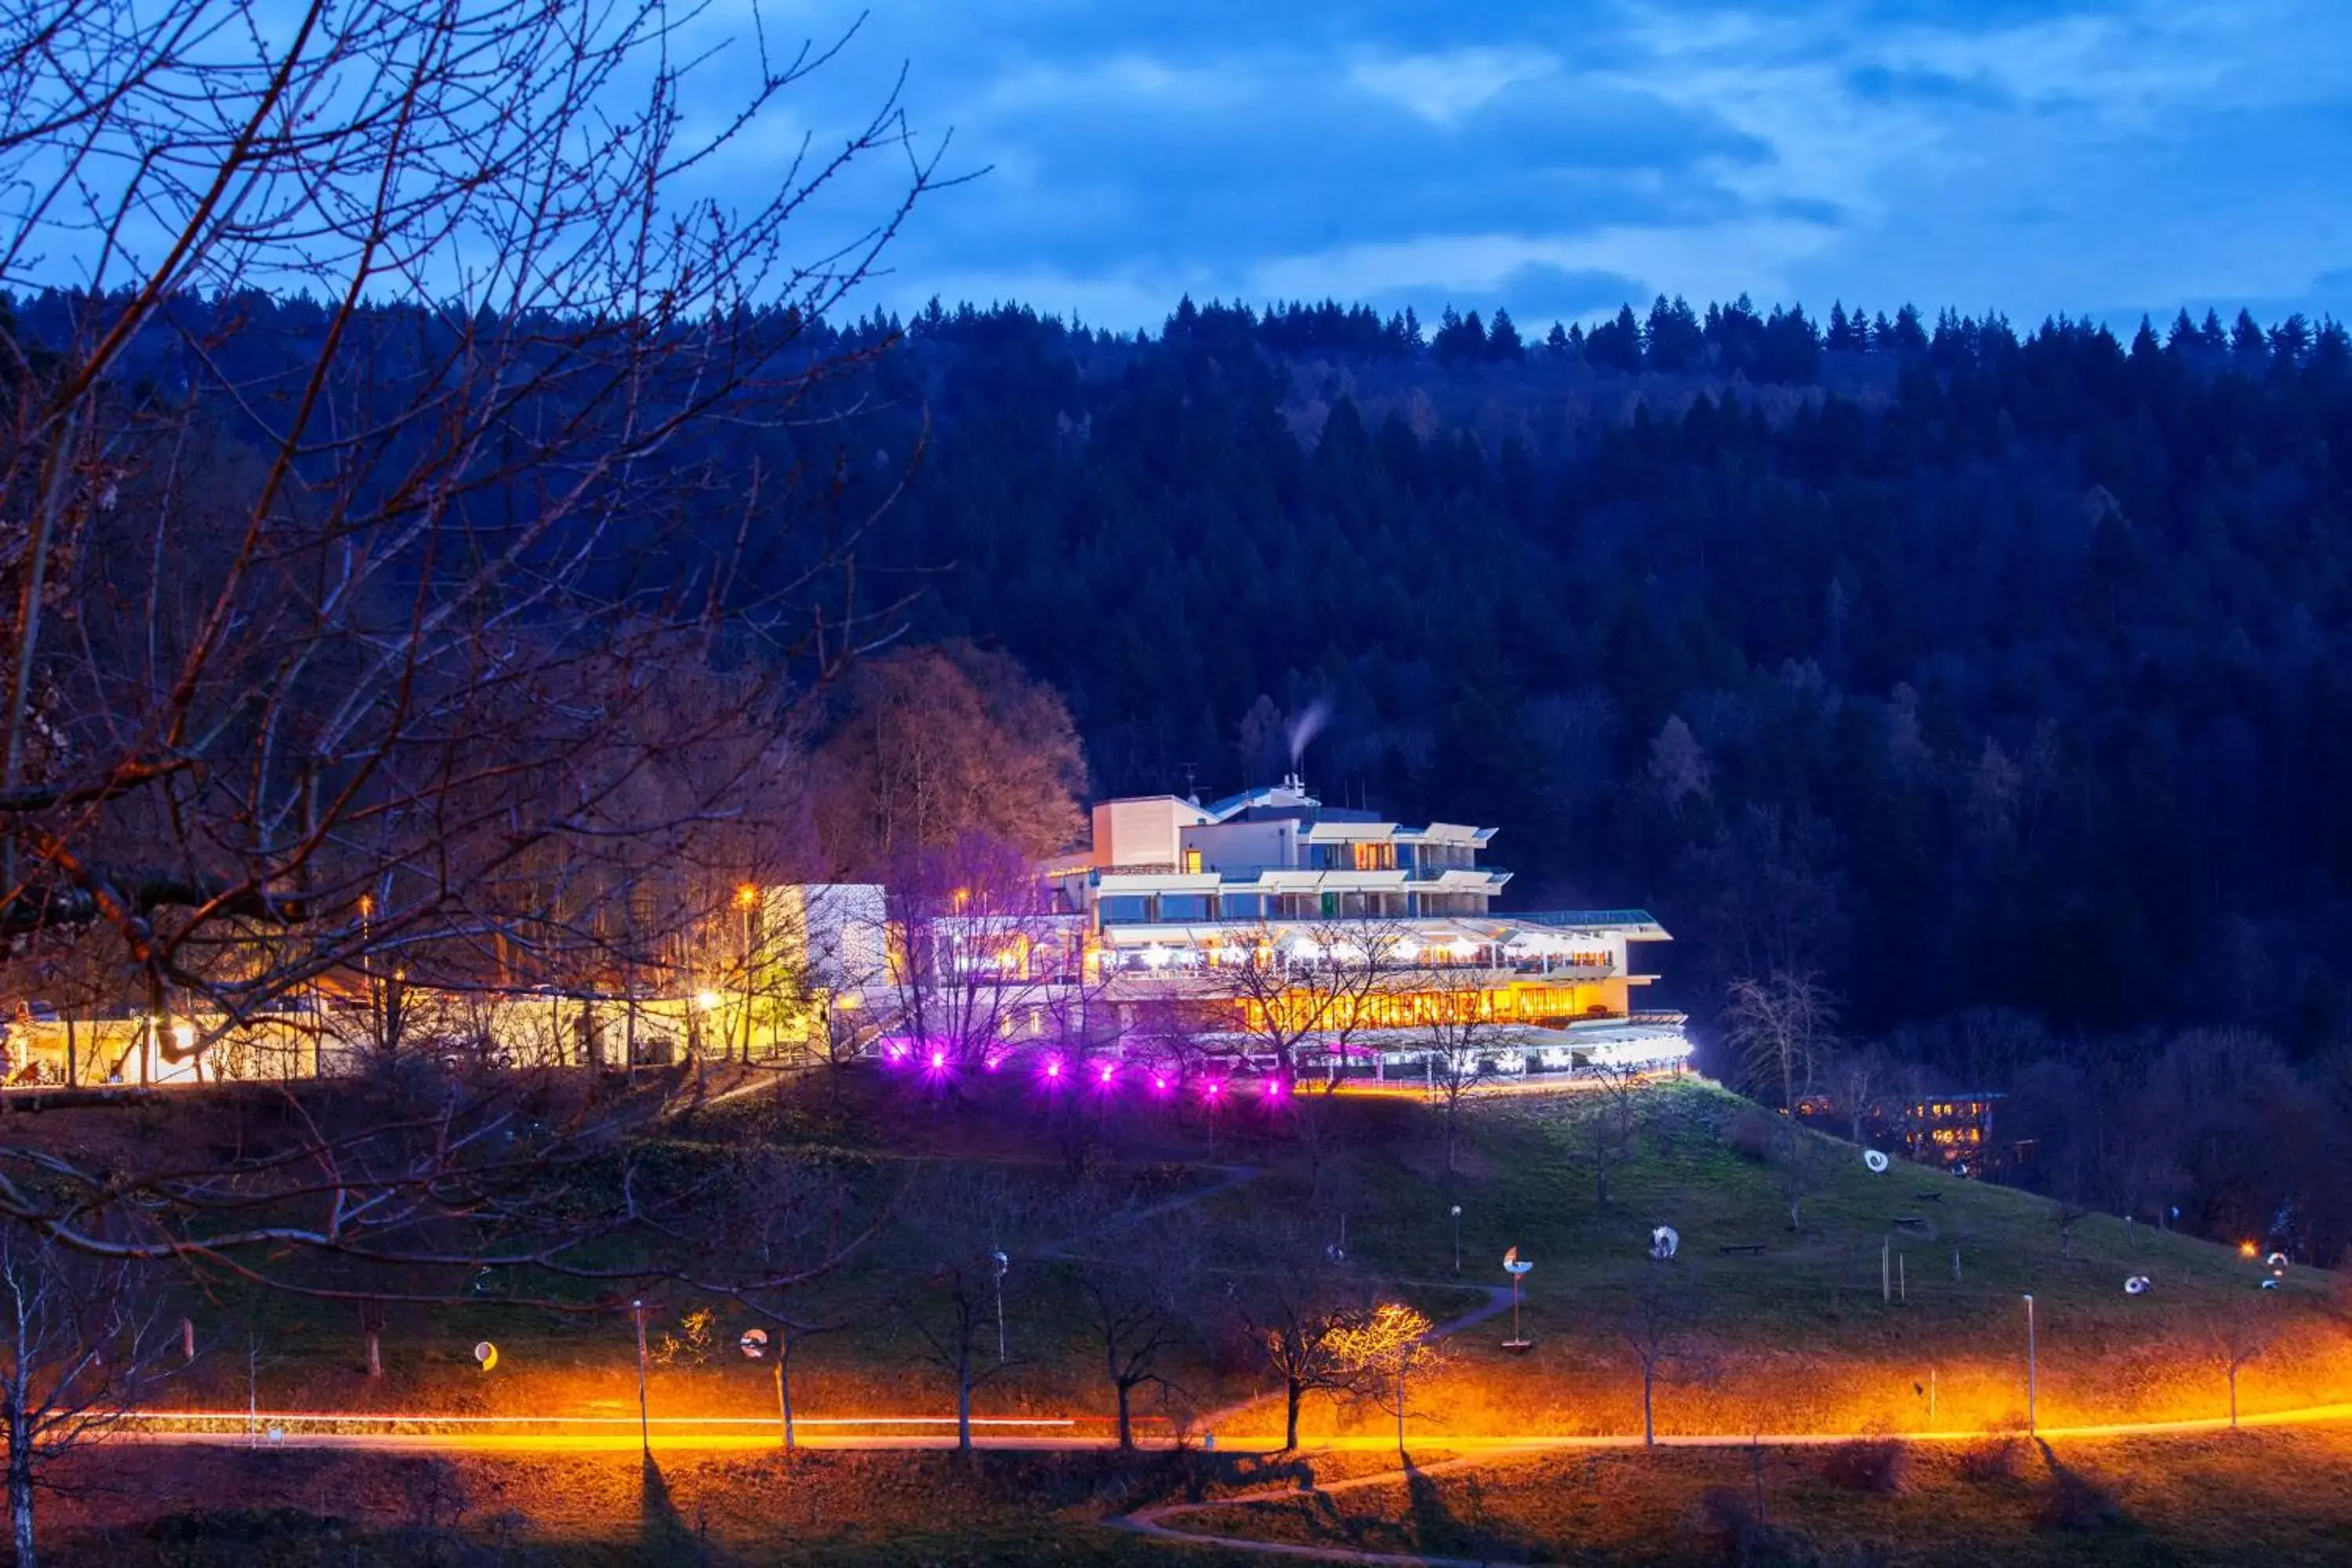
[{"x1": 0, "y1": 1229, "x2": 179, "y2": 1568}]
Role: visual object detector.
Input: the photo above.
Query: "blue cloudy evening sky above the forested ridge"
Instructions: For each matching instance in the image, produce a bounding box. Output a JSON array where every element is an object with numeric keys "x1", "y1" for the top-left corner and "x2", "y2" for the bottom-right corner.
[{"x1": 727, "y1": 0, "x2": 2352, "y2": 327}]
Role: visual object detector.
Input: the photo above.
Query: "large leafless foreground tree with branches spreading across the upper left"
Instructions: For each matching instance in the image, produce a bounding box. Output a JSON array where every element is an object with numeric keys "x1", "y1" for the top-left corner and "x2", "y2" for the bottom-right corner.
[{"x1": 0, "y1": 0, "x2": 931, "y2": 1293}]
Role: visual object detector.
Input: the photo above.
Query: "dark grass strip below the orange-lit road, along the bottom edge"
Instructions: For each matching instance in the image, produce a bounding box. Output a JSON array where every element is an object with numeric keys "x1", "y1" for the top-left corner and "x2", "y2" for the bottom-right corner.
[{"x1": 45, "y1": 1427, "x2": 2352, "y2": 1568}]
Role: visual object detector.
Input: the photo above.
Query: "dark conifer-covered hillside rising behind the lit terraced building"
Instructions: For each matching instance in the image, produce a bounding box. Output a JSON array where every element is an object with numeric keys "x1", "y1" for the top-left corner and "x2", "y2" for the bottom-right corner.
[{"x1": 12, "y1": 296, "x2": 2352, "y2": 1053}]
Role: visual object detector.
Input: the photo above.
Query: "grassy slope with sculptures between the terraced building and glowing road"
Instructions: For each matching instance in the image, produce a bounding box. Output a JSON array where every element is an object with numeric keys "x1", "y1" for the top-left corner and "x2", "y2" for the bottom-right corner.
[{"x1": 87, "y1": 1074, "x2": 2352, "y2": 1443}]
